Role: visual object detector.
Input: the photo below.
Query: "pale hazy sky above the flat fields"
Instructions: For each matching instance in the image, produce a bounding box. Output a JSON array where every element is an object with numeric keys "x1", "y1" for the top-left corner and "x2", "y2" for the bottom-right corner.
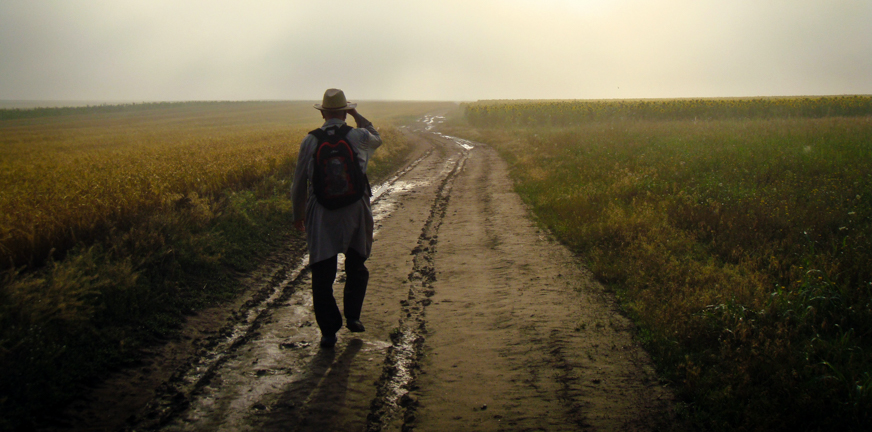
[{"x1": 0, "y1": 0, "x2": 872, "y2": 101}]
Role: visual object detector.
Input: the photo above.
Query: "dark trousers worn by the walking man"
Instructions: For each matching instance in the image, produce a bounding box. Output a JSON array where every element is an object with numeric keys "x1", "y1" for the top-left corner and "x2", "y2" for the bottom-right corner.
[{"x1": 311, "y1": 249, "x2": 369, "y2": 335}]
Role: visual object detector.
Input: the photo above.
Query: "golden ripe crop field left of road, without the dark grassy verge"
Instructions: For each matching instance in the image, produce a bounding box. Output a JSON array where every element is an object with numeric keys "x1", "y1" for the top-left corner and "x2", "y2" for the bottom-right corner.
[{"x1": 0, "y1": 102, "x2": 450, "y2": 268}]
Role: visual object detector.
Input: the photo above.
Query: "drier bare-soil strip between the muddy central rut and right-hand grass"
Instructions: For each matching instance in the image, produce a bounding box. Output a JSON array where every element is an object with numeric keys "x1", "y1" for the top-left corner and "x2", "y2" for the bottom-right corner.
[{"x1": 406, "y1": 132, "x2": 671, "y2": 431}]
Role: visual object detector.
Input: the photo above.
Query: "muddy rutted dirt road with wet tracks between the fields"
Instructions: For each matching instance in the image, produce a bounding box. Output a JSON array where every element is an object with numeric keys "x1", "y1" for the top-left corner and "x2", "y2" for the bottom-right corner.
[{"x1": 114, "y1": 117, "x2": 670, "y2": 431}]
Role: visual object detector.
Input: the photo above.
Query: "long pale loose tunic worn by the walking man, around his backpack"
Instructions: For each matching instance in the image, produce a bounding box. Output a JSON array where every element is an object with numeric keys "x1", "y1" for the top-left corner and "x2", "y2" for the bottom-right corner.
[{"x1": 291, "y1": 119, "x2": 382, "y2": 263}]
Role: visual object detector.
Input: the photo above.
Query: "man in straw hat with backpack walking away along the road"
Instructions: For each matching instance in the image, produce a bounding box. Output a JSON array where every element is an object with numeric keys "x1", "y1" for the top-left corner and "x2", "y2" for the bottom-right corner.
[{"x1": 291, "y1": 89, "x2": 382, "y2": 348}]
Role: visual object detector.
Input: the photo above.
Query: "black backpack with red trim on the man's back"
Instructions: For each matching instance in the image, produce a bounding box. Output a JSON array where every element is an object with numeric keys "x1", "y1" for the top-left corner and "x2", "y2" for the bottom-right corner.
[{"x1": 309, "y1": 125, "x2": 369, "y2": 210}]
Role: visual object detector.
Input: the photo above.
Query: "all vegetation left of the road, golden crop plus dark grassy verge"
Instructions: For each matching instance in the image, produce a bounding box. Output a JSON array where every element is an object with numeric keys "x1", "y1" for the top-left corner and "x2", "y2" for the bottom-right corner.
[{"x1": 0, "y1": 102, "x2": 444, "y2": 429}]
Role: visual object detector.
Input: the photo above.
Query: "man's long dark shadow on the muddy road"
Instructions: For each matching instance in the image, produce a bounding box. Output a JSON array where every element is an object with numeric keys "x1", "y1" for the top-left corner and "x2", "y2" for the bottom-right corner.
[{"x1": 262, "y1": 339, "x2": 363, "y2": 431}]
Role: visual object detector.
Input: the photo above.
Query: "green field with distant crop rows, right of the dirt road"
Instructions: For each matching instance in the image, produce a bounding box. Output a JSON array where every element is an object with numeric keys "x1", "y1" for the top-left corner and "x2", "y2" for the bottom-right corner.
[{"x1": 449, "y1": 96, "x2": 872, "y2": 430}]
